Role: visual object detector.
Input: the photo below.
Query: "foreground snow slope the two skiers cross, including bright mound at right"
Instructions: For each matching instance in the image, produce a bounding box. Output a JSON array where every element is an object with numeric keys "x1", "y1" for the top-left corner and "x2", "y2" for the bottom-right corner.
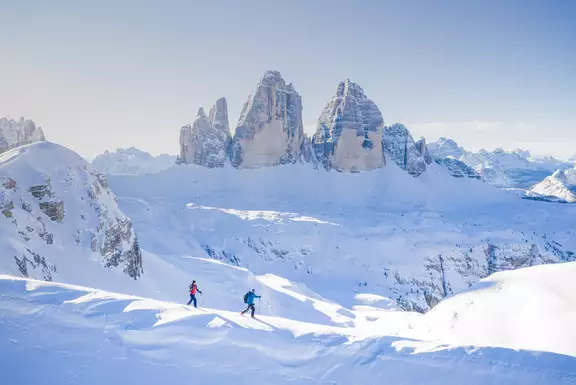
[{"x1": 0, "y1": 264, "x2": 576, "y2": 385}]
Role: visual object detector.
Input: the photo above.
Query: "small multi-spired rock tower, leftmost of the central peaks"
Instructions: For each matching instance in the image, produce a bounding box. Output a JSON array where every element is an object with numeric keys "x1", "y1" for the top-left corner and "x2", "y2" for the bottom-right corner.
[{"x1": 179, "y1": 98, "x2": 231, "y2": 167}]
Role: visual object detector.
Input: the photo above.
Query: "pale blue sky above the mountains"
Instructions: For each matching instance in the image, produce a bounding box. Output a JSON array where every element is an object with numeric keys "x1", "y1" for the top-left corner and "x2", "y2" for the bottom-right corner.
[{"x1": 0, "y1": 0, "x2": 576, "y2": 157}]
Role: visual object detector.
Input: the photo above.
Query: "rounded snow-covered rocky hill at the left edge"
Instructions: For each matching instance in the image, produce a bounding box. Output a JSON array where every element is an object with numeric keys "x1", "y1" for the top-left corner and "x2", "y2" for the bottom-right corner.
[{"x1": 0, "y1": 142, "x2": 142, "y2": 284}]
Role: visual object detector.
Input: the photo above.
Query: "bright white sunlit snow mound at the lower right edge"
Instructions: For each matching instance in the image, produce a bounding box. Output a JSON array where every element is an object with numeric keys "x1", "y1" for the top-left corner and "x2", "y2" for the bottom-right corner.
[{"x1": 424, "y1": 262, "x2": 576, "y2": 356}]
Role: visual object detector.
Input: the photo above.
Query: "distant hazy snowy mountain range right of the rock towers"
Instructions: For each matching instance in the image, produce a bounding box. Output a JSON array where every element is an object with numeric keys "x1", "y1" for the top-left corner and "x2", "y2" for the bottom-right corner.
[{"x1": 428, "y1": 138, "x2": 571, "y2": 189}]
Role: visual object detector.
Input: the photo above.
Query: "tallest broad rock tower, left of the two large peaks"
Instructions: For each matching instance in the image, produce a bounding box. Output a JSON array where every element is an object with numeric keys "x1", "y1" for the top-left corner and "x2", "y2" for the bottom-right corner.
[{"x1": 230, "y1": 71, "x2": 304, "y2": 168}]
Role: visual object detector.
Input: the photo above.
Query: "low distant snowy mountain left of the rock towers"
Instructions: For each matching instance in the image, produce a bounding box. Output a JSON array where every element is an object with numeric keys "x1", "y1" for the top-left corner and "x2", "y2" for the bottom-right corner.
[{"x1": 92, "y1": 147, "x2": 176, "y2": 175}]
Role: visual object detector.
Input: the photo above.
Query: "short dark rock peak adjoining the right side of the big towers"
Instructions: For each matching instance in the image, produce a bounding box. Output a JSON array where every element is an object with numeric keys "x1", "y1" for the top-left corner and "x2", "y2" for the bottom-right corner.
[{"x1": 382, "y1": 123, "x2": 426, "y2": 176}]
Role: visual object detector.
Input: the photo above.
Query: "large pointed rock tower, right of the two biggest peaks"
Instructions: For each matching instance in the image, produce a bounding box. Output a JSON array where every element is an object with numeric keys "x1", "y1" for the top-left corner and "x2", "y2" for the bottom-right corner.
[{"x1": 312, "y1": 79, "x2": 385, "y2": 171}]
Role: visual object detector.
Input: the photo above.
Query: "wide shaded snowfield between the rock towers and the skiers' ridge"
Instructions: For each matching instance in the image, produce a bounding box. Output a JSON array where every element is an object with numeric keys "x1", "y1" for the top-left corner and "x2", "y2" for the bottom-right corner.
[{"x1": 110, "y1": 163, "x2": 576, "y2": 311}]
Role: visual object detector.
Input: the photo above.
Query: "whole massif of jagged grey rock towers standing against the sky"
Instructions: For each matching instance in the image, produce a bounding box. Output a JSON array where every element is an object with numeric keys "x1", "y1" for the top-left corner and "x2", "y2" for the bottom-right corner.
[{"x1": 177, "y1": 71, "x2": 479, "y2": 179}]
